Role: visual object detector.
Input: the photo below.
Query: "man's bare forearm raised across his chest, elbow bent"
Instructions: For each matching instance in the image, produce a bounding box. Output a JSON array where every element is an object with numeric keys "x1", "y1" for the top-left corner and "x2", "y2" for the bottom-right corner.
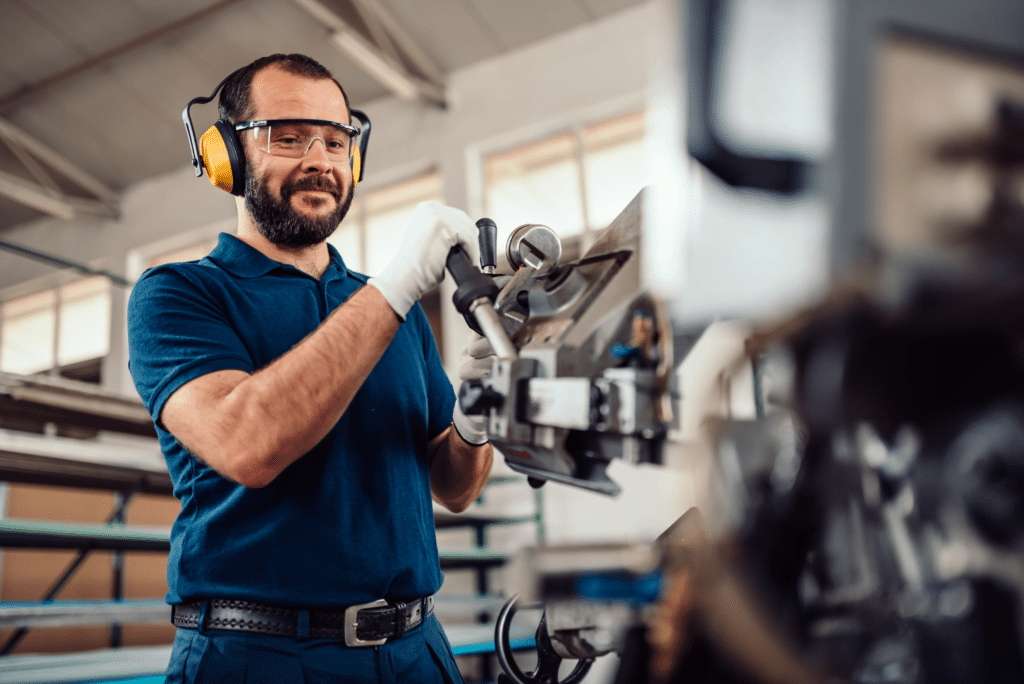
[{"x1": 163, "y1": 287, "x2": 400, "y2": 486}]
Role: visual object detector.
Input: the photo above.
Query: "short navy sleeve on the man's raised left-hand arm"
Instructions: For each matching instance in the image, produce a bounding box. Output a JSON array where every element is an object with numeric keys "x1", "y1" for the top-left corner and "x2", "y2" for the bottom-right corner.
[{"x1": 128, "y1": 264, "x2": 255, "y2": 423}]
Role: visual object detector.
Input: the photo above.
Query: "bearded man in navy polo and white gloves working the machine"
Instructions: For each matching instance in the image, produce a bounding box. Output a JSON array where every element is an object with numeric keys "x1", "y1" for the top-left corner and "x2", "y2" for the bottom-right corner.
[{"x1": 128, "y1": 54, "x2": 493, "y2": 683}]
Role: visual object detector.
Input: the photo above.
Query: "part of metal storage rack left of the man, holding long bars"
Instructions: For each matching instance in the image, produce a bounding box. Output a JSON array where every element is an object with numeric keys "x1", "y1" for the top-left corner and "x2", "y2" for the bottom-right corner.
[{"x1": 0, "y1": 373, "x2": 172, "y2": 655}]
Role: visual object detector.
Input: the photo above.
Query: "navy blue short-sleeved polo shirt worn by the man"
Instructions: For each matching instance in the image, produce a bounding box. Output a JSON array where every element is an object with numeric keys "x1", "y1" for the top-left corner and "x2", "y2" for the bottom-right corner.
[{"x1": 128, "y1": 233, "x2": 455, "y2": 607}]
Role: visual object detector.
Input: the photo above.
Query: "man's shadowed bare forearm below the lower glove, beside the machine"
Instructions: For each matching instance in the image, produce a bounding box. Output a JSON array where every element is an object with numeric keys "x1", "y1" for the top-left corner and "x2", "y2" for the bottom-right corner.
[{"x1": 430, "y1": 426, "x2": 495, "y2": 513}]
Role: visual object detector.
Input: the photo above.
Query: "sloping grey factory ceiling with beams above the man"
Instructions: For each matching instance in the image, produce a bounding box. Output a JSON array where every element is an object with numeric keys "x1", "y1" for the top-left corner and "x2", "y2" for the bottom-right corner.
[{"x1": 0, "y1": 0, "x2": 645, "y2": 234}]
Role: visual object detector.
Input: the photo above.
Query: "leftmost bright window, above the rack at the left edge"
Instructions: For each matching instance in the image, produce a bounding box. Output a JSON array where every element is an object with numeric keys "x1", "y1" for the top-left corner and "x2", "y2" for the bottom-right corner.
[{"x1": 0, "y1": 275, "x2": 111, "y2": 382}]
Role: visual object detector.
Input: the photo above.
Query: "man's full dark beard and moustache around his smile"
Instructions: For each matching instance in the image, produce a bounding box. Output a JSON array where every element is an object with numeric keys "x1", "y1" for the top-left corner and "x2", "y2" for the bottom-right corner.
[{"x1": 246, "y1": 165, "x2": 352, "y2": 249}]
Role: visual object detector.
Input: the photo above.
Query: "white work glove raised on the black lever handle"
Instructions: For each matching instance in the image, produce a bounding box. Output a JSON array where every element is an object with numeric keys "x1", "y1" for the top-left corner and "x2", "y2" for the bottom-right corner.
[{"x1": 369, "y1": 202, "x2": 479, "y2": 320}]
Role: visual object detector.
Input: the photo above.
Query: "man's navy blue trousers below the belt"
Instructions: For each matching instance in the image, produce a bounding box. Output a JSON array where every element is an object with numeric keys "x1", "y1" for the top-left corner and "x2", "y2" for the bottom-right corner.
[{"x1": 165, "y1": 615, "x2": 463, "y2": 684}]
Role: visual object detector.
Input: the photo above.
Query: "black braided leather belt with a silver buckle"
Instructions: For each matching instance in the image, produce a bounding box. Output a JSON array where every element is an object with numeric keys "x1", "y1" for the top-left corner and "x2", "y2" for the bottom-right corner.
[{"x1": 171, "y1": 596, "x2": 434, "y2": 647}]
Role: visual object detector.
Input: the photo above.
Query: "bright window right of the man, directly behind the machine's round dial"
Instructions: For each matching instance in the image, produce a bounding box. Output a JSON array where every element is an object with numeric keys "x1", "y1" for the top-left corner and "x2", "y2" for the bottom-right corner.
[{"x1": 484, "y1": 112, "x2": 647, "y2": 245}]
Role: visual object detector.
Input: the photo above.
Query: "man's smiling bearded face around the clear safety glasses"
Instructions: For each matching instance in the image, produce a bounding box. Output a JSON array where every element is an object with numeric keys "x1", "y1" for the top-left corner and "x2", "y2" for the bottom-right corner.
[{"x1": 242, "y1": 66, "x2": 353, "y2": 248}]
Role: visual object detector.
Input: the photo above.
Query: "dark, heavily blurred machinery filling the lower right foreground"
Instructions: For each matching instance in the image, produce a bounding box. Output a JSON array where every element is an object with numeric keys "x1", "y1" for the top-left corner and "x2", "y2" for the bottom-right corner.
[{"x1": 473, "y1": 100, "x2": 1024, "y2": 684}]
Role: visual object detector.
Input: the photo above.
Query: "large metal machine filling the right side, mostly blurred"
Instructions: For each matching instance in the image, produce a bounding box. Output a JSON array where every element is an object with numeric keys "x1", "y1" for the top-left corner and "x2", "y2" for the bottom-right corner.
[{"x1": 450, "y1": 0, "x2": 1024, "y2": 684}]
